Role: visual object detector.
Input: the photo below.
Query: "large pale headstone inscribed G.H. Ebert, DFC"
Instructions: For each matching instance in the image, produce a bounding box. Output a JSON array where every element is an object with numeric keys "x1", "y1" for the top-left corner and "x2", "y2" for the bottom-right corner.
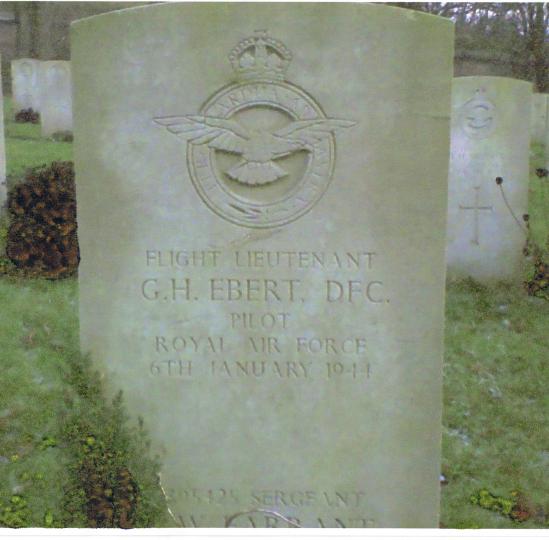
[{"x1": 71, "y1": 3, "x2": 453, "y2": 527}]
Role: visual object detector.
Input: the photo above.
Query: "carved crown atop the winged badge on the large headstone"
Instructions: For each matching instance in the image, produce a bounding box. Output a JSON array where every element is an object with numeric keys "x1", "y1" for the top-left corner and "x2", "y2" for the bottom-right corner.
[{"x1": 229, "y1": 30, "x2": 292, "y2": 80}]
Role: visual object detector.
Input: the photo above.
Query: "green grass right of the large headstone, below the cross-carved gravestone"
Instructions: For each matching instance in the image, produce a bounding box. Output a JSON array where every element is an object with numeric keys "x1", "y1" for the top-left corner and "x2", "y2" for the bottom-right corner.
[{"x1": 441, "y1": 282, "x2": 549, "y2": 528}]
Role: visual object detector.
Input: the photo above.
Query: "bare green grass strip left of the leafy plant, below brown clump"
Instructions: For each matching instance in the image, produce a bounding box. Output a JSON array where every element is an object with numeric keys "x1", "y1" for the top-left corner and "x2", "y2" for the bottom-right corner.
[{"x1": 0, "y1": 280, "x2": 77, "y2": 526}]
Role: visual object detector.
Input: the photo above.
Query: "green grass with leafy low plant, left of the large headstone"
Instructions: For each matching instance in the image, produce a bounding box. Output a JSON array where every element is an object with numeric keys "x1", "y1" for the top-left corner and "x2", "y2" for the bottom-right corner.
[{"x1": 0, "y1": 277, "x2": 167, "y2": 527}]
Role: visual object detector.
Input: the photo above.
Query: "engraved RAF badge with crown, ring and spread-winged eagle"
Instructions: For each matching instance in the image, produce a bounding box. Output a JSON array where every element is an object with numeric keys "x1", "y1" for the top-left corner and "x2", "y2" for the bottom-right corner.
[{"x1": 154, "y1": 31, "x2": 355, "y2": 228}]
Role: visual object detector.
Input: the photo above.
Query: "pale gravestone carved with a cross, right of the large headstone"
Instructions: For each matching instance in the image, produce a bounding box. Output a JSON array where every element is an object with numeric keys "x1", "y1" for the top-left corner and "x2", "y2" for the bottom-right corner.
[{"x1": 447, "y1": 77, "x2": 531, "y2": 283}]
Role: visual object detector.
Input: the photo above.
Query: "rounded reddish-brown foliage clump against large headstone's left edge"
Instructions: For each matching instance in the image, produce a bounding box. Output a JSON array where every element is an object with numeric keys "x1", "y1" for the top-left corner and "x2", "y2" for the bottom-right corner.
[{"x1": 6, "y1": 161, "x2": 80, "y2": 279}]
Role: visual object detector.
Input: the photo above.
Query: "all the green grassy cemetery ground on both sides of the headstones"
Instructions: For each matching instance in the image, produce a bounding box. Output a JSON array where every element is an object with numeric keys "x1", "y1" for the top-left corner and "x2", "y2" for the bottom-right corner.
[{"x1": 0, "y1": 99, "x2": 549, "y2": 528}]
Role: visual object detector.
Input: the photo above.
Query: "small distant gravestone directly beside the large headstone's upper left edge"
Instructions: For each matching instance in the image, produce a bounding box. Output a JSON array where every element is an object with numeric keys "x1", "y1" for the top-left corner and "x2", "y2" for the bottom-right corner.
[{"x1": 40, "y1": 60, "x2": 72, "y2": 137}]
